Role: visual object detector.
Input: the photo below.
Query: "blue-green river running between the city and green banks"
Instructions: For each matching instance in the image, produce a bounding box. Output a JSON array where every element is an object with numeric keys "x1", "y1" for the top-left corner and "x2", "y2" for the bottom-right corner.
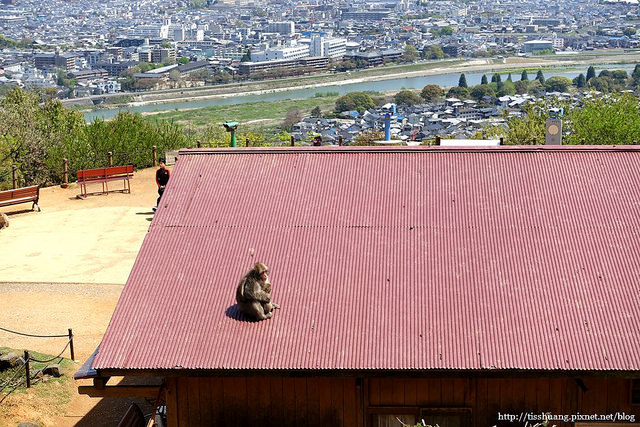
[{"x1": 84, "y1": 64, "x2": 635, "y2": 121}]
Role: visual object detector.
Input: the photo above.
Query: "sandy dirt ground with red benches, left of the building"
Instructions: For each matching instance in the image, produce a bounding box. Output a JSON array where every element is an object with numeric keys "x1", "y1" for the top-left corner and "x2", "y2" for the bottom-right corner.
[{"x1": 0, "y1": 169, "x2": 168, "y2": 427}]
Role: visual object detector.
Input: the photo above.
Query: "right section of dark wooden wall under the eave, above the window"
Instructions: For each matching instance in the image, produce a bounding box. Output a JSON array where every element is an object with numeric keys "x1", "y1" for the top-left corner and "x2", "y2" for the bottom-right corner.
[{"x1": 365, "y1": 378, "x2": 640, "y2": 427}]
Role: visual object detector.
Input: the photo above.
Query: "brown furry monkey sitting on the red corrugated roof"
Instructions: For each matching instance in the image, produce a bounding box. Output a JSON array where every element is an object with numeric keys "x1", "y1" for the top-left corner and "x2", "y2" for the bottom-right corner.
[{"x1": 236, "y1": 262, "x2": 280, "y2": 320}]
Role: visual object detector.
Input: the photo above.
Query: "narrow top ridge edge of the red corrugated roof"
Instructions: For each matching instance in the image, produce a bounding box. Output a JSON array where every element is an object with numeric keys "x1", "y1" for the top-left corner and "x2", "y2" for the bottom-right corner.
[{"x1": 178, "y1": 145, "x2": 640, "y2": 156}]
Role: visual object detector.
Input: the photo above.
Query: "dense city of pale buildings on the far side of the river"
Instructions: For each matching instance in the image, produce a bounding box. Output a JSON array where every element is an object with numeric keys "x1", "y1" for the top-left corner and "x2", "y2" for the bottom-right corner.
[{"x1": 0, "y1": 0, "x2": 640, "y2": 94}]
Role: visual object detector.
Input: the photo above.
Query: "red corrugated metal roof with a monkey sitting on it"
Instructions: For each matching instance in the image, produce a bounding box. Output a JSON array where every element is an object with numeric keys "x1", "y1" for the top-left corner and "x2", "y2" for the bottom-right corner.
[{"x1": 93, "y1": 147, "x2": 640, "y2": 370}]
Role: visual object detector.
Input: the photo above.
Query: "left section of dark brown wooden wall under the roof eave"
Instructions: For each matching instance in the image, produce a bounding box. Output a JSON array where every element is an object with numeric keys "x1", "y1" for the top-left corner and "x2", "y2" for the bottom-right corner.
[{"x1": 167, "y1": 378, "x2": 362, "y2": 427}]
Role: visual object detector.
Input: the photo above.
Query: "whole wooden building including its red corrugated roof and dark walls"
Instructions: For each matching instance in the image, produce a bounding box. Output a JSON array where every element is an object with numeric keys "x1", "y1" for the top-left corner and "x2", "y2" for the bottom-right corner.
[{"x1": 76, "y1": 147, "x2": 640, "y2": 427}]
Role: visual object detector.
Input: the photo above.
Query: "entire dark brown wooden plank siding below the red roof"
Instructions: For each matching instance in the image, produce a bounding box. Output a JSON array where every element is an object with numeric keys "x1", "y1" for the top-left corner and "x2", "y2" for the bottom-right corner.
[{"x1": 166, "y1": 377, "x2": 640, "y2": 427}]
